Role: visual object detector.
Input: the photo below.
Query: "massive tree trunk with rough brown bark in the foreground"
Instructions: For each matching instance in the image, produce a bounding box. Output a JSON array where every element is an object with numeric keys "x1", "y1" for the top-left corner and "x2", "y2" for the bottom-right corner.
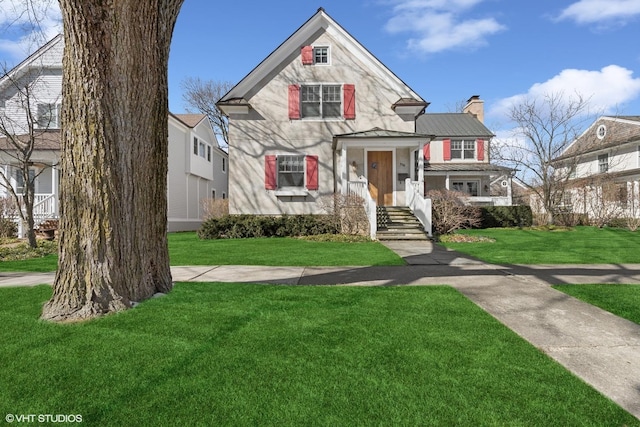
[{"x1": 42, "y1": 0, "x2": 183, "y2": 321}]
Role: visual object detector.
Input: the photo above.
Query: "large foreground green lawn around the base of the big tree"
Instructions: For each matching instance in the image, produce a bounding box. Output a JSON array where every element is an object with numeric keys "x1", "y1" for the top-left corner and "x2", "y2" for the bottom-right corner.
[{"x1": 0, "y1": 283, "x2": 640, "y2": 426}]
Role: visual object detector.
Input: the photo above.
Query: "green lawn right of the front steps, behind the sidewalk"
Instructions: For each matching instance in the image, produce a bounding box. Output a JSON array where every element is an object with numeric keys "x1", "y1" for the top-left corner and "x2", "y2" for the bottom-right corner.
[{"x1": 443, "y1": 227, "x2": 640, "y2": 264}]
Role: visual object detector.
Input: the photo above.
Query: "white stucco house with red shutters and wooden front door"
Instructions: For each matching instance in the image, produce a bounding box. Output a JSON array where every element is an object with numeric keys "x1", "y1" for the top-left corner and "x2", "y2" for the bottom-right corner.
[{"x1": 217, "y1": 8, "x2": 508, "y2": 236}]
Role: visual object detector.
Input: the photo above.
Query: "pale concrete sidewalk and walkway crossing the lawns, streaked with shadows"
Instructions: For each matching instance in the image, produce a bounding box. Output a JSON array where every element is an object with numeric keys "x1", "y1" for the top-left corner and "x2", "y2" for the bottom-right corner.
[{"x1": 0, "y1": 242, "x2": 640, "y2": 419}]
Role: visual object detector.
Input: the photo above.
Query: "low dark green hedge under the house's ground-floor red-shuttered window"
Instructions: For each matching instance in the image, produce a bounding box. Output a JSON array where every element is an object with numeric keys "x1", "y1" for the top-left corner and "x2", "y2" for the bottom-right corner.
[{"x1": 198, "y1": 215, "x2": 340, "y2": 239}]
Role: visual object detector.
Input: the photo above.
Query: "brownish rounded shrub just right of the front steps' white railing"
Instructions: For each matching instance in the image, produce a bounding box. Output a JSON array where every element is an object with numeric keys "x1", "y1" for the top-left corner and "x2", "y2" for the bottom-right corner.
[{"x1": 427, "y1": 190, "x2": 480, "y2": 234}]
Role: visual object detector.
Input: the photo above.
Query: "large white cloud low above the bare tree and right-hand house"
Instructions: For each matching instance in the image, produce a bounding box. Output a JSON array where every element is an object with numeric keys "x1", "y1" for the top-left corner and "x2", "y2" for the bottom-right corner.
[{"x1": 489, "y1": 65, "x2": 640, "y2": 117}]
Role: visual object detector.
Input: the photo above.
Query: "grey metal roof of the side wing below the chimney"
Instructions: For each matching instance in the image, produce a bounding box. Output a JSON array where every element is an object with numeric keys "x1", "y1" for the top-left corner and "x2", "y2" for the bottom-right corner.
[{"x1": 416, "y1": 113, "x2": 495, "y2": 138}]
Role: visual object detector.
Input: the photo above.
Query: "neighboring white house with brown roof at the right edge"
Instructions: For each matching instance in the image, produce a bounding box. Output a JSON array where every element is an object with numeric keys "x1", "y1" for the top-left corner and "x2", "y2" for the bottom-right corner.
[{"x1": 554, "y1": 116, "x2": 640, "y2": 221}]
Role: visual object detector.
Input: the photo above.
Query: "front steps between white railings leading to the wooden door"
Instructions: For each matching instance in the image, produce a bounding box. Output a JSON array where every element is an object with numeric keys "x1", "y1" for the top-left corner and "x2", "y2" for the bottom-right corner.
[{"x1": 376, "y1": 206, "x2": 429, "y2": 240}]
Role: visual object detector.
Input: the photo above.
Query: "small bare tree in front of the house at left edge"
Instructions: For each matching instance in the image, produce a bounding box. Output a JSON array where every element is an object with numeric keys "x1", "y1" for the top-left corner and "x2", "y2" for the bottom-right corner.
[{"x1": 0, "y1": 67, "x2": 59, "y2": 248}]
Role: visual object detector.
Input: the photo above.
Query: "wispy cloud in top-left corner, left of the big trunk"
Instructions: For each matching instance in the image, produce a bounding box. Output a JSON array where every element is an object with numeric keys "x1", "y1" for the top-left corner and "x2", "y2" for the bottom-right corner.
[{"x1": 0, "y1": 0, "x2": 62, "y2": 61}]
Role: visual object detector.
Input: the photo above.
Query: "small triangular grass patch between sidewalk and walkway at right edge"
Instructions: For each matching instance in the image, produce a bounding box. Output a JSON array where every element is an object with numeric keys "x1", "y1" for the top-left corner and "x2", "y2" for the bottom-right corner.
[{"x1": 554, "y1": 285, "x2": 640, "y2": 325}]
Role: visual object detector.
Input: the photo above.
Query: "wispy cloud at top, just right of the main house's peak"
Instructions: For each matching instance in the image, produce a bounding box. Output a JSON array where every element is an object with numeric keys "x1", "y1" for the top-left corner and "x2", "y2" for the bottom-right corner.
[{"x1": 385, "y1": 0, "x2": 506, "y2": 53}]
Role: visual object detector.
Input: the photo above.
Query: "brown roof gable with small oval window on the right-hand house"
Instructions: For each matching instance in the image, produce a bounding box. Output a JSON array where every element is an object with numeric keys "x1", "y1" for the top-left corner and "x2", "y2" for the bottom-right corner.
[{"x1": 553, "y1": 116, "x2": 640, "y2": 161}]
